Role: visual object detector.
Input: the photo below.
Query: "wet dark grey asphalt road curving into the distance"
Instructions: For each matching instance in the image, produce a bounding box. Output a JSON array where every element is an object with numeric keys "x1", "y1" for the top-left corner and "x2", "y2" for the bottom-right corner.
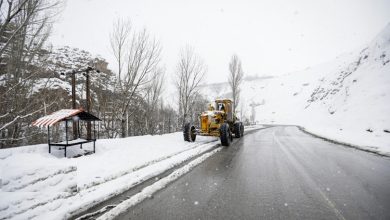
[{"x1": 118, "y1": 126, "x2": 390, "y2": 220}]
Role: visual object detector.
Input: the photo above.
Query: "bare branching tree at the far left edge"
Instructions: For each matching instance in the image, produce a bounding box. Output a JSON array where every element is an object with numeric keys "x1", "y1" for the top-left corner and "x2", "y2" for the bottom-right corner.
[{"x1": 0, "y1": 0, "x2": 61, "y2": 146}]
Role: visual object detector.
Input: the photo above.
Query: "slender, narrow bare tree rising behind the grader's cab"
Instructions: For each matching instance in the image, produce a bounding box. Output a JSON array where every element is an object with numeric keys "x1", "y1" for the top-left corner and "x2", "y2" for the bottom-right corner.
[{"x1": 229, "y1": 54, "x2": 244, "y2": 112}]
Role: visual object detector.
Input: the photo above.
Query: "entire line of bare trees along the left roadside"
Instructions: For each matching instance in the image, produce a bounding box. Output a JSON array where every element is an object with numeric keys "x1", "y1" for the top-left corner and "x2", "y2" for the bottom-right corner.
[{"x1": 0, "y1": 0, "x2": 243, "y2": 148}]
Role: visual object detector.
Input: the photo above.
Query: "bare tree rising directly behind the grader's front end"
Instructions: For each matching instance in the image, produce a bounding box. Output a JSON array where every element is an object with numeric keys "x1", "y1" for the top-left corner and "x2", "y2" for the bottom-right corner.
[{"x1": 176, "y1": 46, "x2": 207, "y2": 126}]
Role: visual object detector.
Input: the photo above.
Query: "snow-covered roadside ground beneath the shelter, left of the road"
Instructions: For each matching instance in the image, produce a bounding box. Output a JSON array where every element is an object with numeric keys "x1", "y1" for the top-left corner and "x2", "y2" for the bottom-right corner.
[{"x1": 0, "y1": 126, "x2": 261, "y2": 219}]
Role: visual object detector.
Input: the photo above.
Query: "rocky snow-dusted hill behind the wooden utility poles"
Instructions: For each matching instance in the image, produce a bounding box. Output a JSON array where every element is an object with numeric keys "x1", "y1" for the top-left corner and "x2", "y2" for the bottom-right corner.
[{"x1": 34, "y1": 46, "x2": 114, "y2": 111}]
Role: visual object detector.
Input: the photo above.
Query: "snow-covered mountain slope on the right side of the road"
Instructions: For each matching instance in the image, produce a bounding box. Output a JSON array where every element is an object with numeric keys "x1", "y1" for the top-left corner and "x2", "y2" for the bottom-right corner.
[{"x1": 203, "y1": 24, "x2": 390, "y2": 151}]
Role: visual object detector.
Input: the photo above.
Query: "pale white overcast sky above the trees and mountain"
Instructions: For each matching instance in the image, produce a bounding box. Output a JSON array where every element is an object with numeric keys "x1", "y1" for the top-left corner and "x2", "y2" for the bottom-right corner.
[{"x1": 50, "y1": 0, "x2": 390, "y2": 82}]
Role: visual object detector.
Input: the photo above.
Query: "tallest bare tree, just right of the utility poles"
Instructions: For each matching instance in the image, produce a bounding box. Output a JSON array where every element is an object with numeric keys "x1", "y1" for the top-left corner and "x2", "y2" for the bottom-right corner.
[{"x1": 111, "y1": 22, "x2": 161, "y2": 137}]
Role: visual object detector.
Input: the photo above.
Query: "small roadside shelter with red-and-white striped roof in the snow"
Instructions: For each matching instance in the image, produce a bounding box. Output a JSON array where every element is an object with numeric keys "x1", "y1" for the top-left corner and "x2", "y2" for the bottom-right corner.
[{"x1": 32, "y1": 109, "x2": 101, "y2": 157}]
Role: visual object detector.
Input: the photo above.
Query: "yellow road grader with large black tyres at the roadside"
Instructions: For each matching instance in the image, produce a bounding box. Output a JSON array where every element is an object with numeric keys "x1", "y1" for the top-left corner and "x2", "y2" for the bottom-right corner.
[{"x1": 183, "y1": 99, "x2": 244, "y2": 146}]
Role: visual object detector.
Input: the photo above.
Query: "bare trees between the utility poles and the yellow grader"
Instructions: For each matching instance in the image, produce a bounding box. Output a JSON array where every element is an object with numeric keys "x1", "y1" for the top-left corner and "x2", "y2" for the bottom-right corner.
[{"x1": 105, "y1": 20, "x2": 207, "y2": 137}]
